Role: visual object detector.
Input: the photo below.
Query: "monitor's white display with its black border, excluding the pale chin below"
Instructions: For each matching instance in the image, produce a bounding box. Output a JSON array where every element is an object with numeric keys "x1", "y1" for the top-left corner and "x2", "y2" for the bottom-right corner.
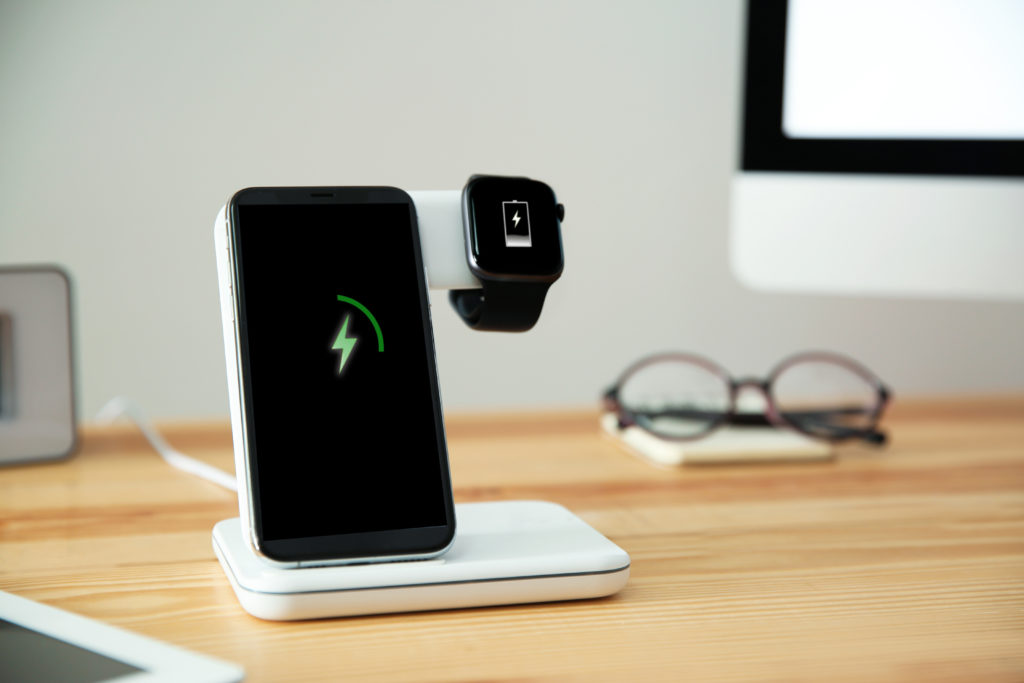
[{"x1": 741, "y1": 0, "x2": 1024, "y2": 176}]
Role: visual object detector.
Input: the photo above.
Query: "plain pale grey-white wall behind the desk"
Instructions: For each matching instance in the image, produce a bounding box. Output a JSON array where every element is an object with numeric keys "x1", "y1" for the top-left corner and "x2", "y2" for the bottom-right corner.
[{"x1": 0, "y1": 0, "x2": 1024, "y2": 418}]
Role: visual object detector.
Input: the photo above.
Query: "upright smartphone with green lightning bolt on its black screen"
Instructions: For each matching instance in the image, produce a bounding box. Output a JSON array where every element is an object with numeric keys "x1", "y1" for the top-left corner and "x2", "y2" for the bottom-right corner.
[{"x1": 216, "y1": 187, "x2": 455, "y2": 567}]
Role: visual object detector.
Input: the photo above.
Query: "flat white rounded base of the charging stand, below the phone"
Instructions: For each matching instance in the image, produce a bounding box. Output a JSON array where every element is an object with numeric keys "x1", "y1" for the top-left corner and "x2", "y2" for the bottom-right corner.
[{"x1": 213, "y1": 501, "x2": 630, "y2": 621}]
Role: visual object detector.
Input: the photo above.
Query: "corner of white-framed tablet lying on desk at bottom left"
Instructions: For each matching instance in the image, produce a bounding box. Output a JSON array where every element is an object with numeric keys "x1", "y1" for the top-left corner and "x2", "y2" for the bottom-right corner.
[{"x1": 0, "y1": 591, "x2": 245, "y2": 683}]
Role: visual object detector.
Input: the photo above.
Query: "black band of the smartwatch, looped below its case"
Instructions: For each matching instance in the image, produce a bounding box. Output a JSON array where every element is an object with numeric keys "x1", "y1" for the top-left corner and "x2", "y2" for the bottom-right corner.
[{"x1": 449, "y1": 281, "x2": 551, "y2": 332}]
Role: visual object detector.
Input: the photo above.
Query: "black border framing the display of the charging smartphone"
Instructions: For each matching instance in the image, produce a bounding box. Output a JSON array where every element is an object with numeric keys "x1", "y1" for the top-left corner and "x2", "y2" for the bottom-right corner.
[{"x1": 228, "y1": 187, "x2": 455, "y2": 565}]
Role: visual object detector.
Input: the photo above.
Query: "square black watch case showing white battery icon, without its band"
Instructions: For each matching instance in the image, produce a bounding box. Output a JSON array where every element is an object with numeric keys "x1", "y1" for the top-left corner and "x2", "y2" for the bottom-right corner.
[{"x1": 464, "y1": 176, "x2": 562, "y2": 278}]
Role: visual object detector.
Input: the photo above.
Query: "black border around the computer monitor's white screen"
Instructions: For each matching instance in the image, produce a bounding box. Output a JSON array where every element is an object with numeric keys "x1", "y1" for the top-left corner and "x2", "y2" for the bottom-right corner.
[{"x1": 740, "y1": 0, "x2": 1024, "y2": 176}]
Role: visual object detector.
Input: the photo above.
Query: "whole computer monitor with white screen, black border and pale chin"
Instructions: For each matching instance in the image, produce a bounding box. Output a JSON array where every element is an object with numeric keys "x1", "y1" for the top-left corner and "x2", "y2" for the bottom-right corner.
[{"x1": 730, "y1": 0, "x2": 1024, "y2": 299}]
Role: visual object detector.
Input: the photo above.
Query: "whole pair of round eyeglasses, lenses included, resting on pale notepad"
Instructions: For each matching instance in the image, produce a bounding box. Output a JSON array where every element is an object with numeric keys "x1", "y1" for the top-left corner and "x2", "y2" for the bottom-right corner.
[{"x1": 604, "y1": 351, "x2": 892, "y2": 444}]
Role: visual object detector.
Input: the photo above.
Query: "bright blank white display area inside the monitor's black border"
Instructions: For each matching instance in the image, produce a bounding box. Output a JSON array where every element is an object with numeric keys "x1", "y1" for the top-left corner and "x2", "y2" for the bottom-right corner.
[{"x1": 782, "y1": 0, "x2": 1024, "y2": 139}]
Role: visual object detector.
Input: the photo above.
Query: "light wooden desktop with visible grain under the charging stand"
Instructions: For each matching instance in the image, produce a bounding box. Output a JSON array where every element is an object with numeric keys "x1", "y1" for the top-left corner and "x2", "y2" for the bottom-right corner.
[{"x1": 0, "y1": 398, "x2": 1024, "y2": 681}]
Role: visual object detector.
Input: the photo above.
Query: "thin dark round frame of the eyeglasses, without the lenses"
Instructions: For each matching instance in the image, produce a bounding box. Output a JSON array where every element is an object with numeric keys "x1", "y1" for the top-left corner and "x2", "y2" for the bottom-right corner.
[{"x1": 602, "y1": 350, "x2": 893, "y2": 445}]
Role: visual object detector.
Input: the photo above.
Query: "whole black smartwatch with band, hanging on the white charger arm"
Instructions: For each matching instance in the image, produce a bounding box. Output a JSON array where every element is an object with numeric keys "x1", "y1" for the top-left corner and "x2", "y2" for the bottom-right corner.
[{"x1": 449, "y1": 175, "x2": 565, "y2": 332}]
